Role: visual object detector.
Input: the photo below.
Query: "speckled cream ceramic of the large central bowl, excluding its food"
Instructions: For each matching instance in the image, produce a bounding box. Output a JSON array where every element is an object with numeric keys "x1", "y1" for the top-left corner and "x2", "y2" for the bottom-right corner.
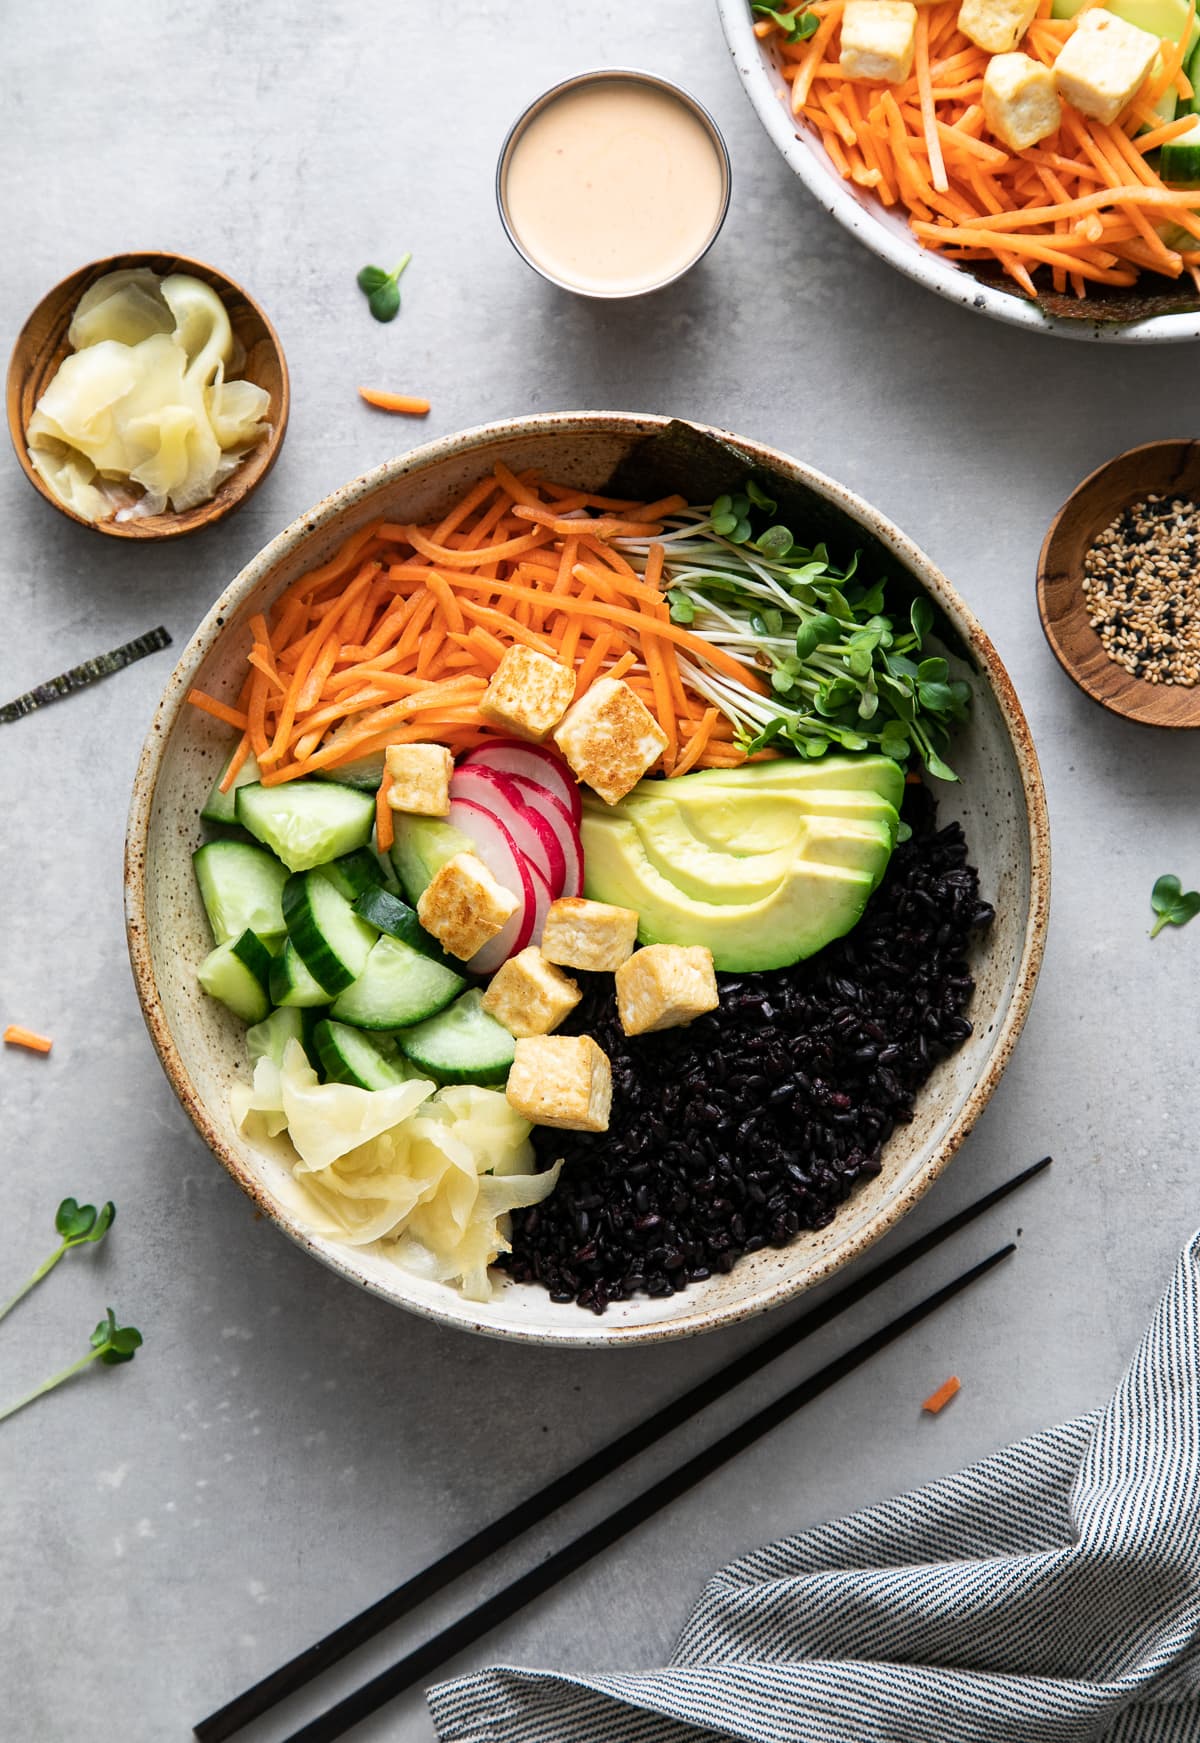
[{"x1": 126, "y1": 413, "x2": 1050, "y2": 1346}]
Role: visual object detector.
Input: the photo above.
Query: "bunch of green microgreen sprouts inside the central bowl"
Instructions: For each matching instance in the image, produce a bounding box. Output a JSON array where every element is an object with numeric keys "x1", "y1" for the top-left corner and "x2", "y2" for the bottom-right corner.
[{"x1": 616, "y1": 495, "x2": 972, "y2": 781}]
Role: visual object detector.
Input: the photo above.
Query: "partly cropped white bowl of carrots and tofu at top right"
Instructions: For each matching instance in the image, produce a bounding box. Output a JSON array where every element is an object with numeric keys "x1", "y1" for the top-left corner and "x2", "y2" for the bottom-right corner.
[{"x1": 717, "y1": 0, "x2": 1200, "y2": 343}]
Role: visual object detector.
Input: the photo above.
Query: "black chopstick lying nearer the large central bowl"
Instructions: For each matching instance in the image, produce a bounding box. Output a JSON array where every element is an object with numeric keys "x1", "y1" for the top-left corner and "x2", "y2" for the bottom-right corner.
[{"x1": 194, "y1": 1156, "x2": 1050, "y2": 1743}]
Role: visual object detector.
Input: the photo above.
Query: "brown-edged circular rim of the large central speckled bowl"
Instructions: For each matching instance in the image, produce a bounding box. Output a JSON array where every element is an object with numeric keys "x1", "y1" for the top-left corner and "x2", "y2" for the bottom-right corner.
[{"x1": 126, "y1": 411, "x2": 1050, "y2": 1347}]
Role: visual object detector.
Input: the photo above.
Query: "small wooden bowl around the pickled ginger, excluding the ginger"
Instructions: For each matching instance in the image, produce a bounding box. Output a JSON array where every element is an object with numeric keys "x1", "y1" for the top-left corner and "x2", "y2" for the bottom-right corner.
[{"x1": 7, "y1": 254, "x2": 291, "y2": 539}]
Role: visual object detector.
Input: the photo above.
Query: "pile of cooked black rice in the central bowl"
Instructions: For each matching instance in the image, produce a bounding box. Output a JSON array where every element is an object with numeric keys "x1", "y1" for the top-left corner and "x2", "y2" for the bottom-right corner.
[{"x1": 502, "y1": 786, "x2": 994, "y2": 1312}]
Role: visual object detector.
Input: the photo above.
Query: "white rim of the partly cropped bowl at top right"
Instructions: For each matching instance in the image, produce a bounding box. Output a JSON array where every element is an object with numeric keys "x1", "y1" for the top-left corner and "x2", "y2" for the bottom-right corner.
[{"x1": 717, "y1": 0, "x2": 1200, "y2": 345}]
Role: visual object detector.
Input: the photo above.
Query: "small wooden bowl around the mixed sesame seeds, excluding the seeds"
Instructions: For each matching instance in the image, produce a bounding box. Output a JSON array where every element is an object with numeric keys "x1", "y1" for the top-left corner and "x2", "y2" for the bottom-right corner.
[{"x1": 1038, "y1": 441, "x2": 1200, "y2": 727}]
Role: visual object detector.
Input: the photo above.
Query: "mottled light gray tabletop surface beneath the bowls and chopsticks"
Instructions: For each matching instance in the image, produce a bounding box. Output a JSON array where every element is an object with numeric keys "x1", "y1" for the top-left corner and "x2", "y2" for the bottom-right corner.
[{"x1": 0, "y1": 0, "x2": 1200, "y2": 1743}]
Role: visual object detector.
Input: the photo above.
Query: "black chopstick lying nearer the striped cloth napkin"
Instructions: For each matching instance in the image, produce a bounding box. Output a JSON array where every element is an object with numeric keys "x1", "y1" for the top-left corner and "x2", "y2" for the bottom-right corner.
[{"x1": 284, "y1": 1241, "x2": 1017, "y2": 1743}]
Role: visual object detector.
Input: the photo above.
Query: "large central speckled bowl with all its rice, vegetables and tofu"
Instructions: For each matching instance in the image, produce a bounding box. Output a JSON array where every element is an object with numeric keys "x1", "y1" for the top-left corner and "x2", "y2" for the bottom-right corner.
[{"x1": 127, "y1": 413, "x2": 1048, "y2": 1344}]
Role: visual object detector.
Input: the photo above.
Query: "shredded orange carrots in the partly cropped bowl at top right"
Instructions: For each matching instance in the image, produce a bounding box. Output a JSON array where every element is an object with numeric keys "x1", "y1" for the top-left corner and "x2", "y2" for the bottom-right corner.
[{"x1": 788, "y1": 0, "x2": 1200, "y2": 298}]
